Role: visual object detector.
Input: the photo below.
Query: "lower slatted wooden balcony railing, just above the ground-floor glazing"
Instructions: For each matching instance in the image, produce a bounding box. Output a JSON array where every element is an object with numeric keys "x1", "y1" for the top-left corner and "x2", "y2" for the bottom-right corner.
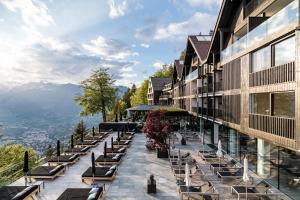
[{"x1": 249, "y1": 114, "x2": 295, "y2": 139}]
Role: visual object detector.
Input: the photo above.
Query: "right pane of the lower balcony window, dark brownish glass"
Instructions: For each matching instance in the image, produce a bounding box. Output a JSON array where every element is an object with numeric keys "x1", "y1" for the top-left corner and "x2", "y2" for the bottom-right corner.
[{"x1": 272, "y1": 92, "x2": 295, "y2": 117}]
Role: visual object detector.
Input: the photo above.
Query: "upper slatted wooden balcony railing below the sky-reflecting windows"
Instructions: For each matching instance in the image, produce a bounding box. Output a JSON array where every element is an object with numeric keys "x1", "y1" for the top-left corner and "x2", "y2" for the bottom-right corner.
[{"x1": 249, "y1": 62, "x2": 295, "y2": 87}]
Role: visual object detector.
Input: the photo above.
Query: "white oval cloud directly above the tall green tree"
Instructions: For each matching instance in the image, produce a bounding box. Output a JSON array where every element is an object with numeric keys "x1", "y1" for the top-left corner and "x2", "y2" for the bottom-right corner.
[{"x1": 82, "y1": 36, "x2": 139, "y2": 59}]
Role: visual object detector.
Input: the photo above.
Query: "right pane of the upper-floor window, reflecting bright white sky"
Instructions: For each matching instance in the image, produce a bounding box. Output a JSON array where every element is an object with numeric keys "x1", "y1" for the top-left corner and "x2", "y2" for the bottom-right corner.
[{"x1": 274, "y1": 37, "x2": 295, "y2": 66}]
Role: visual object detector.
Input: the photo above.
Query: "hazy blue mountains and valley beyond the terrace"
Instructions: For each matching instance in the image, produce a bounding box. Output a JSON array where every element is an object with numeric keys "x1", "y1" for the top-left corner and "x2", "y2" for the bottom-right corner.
[{"x1": 0, "y1": 82, "x2": 128, "y2": 152}]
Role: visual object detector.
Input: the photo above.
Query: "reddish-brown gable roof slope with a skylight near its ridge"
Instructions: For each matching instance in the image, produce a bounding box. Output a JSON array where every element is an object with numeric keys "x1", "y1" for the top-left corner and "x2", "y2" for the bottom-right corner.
[{"x1": 188, "y1": 35, "x2": 211, "y2": 62}]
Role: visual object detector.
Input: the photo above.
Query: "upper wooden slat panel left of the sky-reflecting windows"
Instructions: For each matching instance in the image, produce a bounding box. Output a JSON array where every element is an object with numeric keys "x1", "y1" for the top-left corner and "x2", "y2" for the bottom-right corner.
[{"x1": 222, "y1": 58, "x2": 241, "y2": 90}]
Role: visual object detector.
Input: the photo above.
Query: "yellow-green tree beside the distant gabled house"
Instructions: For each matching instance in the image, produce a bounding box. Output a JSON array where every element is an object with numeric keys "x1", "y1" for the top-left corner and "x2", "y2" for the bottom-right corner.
[{"x1": 131, "y1": 80, "x2": 149, "y2": 106}]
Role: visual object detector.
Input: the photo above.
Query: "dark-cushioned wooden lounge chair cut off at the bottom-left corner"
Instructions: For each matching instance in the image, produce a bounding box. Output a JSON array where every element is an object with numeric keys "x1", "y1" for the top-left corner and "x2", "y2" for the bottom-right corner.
[{"x1": 0, "y1": 185, "x2": 39, "y2": 200}]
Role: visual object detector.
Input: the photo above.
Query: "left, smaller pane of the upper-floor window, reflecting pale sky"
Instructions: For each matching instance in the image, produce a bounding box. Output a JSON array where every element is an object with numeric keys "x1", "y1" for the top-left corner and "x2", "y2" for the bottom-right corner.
[{"x1": 251, "y1": 46, "x2": 271, "y2": 72}]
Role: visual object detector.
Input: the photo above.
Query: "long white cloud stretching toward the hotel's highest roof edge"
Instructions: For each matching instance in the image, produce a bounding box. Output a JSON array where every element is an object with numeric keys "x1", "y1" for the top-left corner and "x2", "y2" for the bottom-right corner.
[{"x1": 135, "y1": 12, "x2": 216, "y2": 41}]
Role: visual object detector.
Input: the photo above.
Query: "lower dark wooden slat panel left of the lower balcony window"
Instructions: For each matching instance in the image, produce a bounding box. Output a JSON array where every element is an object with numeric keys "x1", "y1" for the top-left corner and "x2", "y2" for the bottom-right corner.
[{"x1": 222, "y1": 94, "x2": 241, "y2": 124}]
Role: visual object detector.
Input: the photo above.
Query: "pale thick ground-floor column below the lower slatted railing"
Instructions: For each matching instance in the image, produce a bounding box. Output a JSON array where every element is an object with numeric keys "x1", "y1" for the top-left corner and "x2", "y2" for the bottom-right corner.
[{"x1": 257, "y1": 139, "x2": 271, "y2": 178}]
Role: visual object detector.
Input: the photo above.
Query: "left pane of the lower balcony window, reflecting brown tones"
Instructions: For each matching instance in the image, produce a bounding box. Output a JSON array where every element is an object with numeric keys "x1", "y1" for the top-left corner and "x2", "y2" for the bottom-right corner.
[{"x1": 250, "y1": 93, "x2": 270, "y2": 115}]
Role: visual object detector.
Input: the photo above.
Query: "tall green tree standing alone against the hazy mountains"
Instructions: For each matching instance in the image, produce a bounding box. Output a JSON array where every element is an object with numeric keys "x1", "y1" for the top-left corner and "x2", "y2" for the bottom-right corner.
[{"x1": 75, "y1": 68, "x2": 117, "y2": 122}]
